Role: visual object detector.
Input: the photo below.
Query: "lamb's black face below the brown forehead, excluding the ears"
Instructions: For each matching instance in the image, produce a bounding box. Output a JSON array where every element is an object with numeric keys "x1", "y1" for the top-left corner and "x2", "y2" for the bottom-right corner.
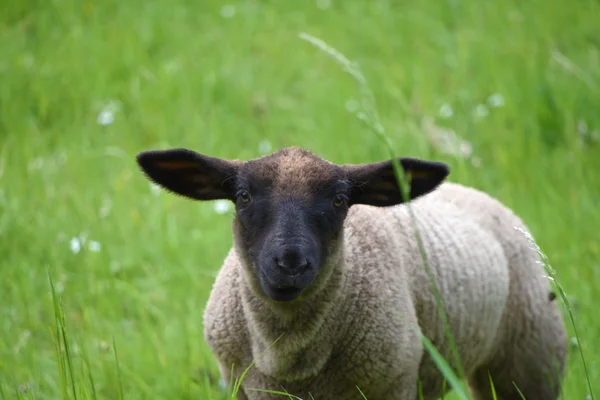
[{"x1": 235, "y1": 167, "x2": 351, "y2": 301}]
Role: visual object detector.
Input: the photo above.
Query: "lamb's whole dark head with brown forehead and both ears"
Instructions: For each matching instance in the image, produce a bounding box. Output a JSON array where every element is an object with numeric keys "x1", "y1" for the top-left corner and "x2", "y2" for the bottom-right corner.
[{"x1": 137, "y1": 147, "x2": 449, "y2": 301}]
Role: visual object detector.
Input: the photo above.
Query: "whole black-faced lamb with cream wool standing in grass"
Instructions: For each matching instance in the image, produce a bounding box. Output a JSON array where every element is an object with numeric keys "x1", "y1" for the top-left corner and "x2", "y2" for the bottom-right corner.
[{"x1": 137, "y1": 147, "x2": 567, "y2": 400}]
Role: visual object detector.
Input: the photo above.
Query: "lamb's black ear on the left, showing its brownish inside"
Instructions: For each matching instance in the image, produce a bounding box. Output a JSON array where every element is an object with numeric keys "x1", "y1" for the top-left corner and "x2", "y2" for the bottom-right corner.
[{"x1": 136, "y1": 149, "x2": 241, "y2": 201}]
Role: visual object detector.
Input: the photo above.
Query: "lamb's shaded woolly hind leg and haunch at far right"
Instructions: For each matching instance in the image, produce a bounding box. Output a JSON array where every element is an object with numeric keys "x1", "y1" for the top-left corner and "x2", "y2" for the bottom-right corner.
[{"x1": 469, "y1": 225, "x2": 568, "y2": 400}]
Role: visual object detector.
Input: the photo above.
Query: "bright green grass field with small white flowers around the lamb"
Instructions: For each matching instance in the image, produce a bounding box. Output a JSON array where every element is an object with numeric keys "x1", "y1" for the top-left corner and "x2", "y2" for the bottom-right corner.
[{"x1": 0, "y1": 0, "x2": 600, "y2": 400}]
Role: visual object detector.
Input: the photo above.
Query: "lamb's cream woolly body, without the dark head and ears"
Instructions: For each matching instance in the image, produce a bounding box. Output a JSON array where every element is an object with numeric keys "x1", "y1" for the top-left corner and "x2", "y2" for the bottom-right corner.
[{"x1": 205, "y1": 183, "x2": 566, "y2": 400}]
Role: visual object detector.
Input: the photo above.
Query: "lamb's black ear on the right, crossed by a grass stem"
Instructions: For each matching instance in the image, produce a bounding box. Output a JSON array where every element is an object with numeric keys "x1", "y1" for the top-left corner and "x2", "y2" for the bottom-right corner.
[{"x1": 344, "y1": 158, "x2": 450, "y2": 207}]
